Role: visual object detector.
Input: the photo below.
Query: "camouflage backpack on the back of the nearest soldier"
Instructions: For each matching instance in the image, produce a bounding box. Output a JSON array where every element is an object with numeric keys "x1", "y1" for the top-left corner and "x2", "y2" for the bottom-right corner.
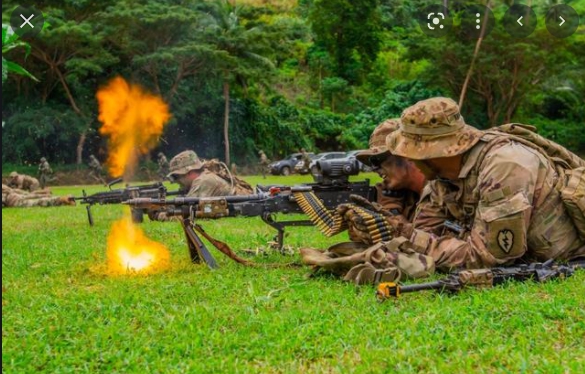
[{"x1": 486, "y1": 123, "x2": 585, "y2": 240}]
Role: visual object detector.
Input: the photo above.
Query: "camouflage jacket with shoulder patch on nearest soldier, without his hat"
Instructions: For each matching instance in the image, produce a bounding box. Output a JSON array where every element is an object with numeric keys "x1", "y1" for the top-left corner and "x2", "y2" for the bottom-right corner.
[{"x1": 401, "y1": 136, "x2": 585, "y2": 270}]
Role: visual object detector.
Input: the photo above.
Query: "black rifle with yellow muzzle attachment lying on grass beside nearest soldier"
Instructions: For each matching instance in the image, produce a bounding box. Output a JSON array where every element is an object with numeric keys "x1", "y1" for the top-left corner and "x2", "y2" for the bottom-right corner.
[{"x1": 376, "y1": 259, "x2": 585, "y2": 301}]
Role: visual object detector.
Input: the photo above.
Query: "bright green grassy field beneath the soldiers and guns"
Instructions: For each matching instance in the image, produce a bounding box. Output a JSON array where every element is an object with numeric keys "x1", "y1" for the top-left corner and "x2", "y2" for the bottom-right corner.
[{"x1": 2, "y1": 176, "x2": 585, "y2": 373}]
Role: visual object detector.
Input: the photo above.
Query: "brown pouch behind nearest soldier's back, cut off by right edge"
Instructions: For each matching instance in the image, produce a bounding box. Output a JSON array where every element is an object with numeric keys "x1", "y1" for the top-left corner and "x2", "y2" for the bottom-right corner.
[{"x1": 561, "y1": 166, "x2": 585, "y2": 240}]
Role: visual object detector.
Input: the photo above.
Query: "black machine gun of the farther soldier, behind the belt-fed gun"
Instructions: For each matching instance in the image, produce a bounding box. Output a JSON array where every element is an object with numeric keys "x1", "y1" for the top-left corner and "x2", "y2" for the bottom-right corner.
[{"x1": 73, "y1": 178, "x2": 179, "y2": 226}]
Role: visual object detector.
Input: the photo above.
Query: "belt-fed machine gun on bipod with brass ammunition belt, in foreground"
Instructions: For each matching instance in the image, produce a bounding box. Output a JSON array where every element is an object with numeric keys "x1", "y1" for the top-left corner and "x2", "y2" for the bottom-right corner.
[{"x1": 124, "y1": 180, "x2": 376, "y2": 268}]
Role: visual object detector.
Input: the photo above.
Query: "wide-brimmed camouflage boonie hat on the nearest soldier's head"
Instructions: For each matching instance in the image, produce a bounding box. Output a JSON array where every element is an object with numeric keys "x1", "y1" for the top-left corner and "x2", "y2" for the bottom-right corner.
[{"x1": 386, "y1": 97, "x2": 482, "y2": 160}]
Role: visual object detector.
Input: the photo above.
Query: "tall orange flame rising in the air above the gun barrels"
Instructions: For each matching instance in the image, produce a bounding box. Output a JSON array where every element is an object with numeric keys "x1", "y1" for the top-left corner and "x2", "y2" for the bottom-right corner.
[{"x1": 96, "y1": 77, "x2": 171, "y2": 179}]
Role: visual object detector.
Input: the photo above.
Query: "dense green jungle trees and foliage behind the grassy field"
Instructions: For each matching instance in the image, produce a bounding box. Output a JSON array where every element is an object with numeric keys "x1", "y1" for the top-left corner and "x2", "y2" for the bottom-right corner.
[{"x1": 2, "y1": 0, "x2": 585, "y2": 165}]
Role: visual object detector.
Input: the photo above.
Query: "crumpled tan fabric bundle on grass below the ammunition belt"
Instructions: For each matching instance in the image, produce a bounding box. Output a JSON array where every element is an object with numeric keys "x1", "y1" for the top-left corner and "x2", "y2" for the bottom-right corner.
[{"x1": 301, "y1": 237, "x2": 435, "y2": 284}]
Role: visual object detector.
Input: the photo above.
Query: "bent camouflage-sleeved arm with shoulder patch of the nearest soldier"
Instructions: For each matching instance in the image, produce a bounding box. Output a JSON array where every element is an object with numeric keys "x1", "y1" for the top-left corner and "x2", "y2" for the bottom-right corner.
[{"x1": 403, "y1": 145, "x2": 541, "y2": 270}]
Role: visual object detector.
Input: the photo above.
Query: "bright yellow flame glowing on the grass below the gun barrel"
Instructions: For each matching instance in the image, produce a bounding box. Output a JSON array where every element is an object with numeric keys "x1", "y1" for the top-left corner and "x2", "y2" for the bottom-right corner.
[{"x1": 107, "y1": 216, "x2": 170, "y2": 274}]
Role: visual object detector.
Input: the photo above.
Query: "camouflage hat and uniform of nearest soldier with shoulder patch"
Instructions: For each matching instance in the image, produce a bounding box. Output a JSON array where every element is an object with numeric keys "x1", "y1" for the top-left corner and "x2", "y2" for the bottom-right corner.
[{"x1": 386, "y1": 98, "x2": 585, "y2": 270}]
